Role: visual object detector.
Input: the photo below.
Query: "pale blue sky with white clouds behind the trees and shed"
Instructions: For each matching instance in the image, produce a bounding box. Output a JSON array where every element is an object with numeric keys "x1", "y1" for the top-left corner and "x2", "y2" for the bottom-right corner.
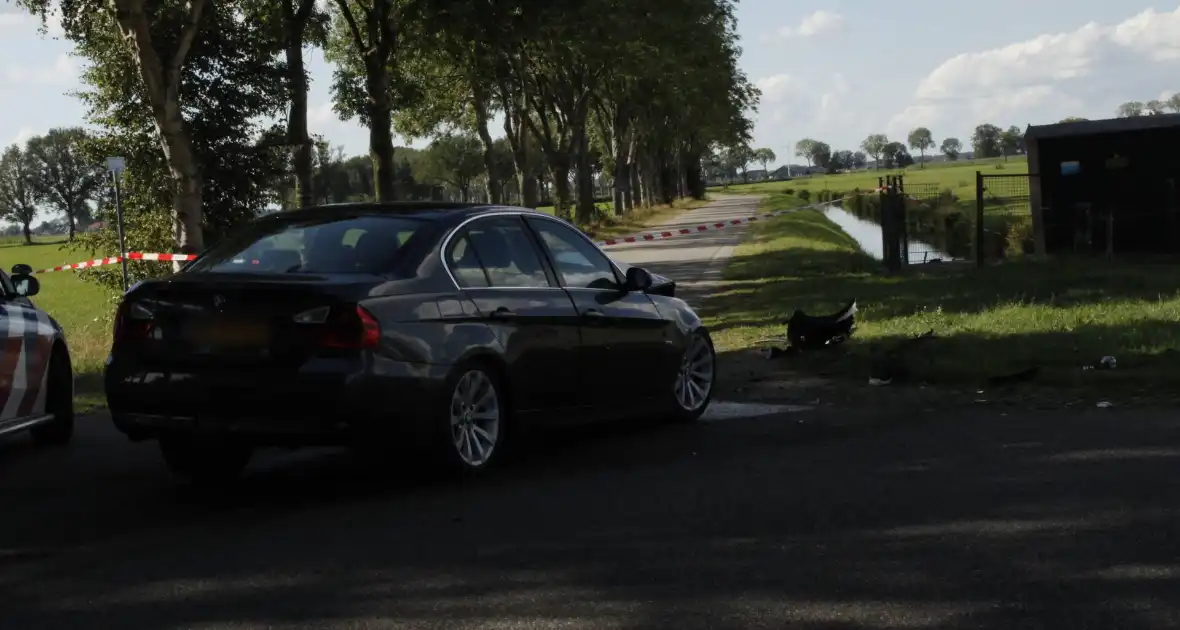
[{"x1": 0, "y1": 0, "x2": 1180, "y2": 169}]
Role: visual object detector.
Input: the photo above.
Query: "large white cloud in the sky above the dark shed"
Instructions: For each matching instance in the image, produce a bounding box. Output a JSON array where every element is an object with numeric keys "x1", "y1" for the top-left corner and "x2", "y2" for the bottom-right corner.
[{"x1": 887, "y1": 8, "x2": 1180, "y2": 136}]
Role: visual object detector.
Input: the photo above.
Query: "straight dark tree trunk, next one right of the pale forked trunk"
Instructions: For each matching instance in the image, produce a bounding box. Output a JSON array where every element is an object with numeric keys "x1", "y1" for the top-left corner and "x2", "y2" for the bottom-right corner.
[{"x1": 283, "y1": 0, "x2": 315, "y2": 208}]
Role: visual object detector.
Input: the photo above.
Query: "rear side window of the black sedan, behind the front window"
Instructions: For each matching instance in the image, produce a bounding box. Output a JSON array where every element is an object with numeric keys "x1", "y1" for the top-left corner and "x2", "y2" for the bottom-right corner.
[{"x1": 447, "y1": 217, "x2": 551, "y2": 288}]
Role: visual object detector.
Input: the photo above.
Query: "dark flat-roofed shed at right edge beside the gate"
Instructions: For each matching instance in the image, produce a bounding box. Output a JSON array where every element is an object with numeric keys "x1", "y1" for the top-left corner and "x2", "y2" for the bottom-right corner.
[{"x1": 1024, "y1": 113, "x2": 1180, "y2": 254}]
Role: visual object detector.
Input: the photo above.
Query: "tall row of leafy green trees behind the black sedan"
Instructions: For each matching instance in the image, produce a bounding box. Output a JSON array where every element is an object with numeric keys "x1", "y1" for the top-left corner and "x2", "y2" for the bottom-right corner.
[{"x1": 11, "y1": 0, "x2": 759, "y2": 264}]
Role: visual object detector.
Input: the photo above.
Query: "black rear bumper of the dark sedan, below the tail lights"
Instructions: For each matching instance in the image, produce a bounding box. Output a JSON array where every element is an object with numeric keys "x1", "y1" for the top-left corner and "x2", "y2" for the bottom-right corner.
[{"x1": 105, "y1": 359, "x2": 448, "y2": 446}]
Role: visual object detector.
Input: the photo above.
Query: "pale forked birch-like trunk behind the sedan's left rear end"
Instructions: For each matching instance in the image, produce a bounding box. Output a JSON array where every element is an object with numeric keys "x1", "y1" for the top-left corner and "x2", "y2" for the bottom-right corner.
[{"x1": 112, "y1": 0, "x2": 208, "y2": 254}]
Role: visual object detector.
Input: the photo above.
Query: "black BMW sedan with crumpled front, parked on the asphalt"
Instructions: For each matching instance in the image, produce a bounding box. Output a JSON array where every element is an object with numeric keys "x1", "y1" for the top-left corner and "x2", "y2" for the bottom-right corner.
[{"x1": 105, "y1": 203, "x2": 715, "y2": 480}]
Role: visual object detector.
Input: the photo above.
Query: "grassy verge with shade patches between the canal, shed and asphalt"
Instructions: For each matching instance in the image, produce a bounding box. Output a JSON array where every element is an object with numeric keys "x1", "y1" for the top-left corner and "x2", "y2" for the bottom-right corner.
[{"x1": 706, "y1": 185, "x2": 1180, "y2": 394}]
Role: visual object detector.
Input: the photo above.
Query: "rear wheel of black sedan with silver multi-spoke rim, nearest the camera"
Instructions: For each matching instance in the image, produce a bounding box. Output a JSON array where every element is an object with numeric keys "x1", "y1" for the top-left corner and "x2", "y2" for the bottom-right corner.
[{"x1": 437, "y1": 361, "x2": 511, "y2": 475}]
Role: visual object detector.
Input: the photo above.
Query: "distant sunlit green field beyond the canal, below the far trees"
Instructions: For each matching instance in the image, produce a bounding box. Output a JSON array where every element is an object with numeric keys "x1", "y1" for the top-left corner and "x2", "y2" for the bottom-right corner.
[{"x1": 709, "y1": 156, "x2": 1028, "y2": 199}]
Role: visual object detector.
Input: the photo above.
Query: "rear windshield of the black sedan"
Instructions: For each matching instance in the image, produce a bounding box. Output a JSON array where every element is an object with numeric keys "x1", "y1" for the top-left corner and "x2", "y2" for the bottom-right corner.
[{"x1": 184, "y1": 216, "x2": 430, "y2": 274}]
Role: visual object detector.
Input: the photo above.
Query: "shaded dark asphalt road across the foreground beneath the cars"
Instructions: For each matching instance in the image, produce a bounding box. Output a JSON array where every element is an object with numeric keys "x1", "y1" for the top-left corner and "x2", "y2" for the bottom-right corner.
[{"x1": 0, "y1": 195, "x2": 1180, "y2": 630}]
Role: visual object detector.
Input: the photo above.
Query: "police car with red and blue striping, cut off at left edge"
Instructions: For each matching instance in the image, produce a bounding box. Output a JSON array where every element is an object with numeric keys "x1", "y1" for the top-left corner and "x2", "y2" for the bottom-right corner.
[{"x1": 0, "y1": 264, "x2": 74, "y2": 446}]
